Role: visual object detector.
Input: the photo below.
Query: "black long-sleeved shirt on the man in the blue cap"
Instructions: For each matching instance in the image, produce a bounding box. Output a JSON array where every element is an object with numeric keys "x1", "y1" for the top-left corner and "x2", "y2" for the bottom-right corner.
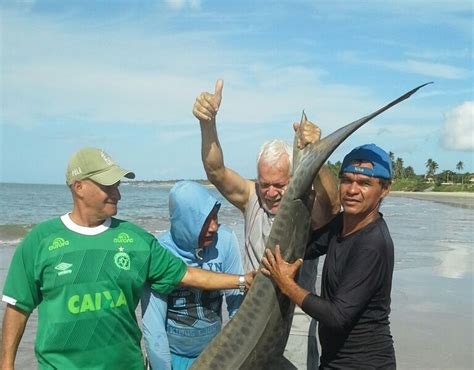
[{"x1": 302, "y1": 213, "x2": 395, "y2": 369}]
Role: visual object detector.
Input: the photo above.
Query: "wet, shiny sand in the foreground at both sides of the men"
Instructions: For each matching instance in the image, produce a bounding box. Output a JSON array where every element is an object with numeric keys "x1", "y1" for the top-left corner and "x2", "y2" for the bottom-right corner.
[{"x1": 0, "y1": 247, "x2": 474, "y2": 370}]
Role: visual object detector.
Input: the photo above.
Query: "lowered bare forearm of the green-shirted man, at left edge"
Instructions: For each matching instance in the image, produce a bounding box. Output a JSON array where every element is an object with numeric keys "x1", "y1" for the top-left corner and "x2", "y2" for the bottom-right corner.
[{"x1": 2, "y1": 304, "x2": 29, "y2": 370}]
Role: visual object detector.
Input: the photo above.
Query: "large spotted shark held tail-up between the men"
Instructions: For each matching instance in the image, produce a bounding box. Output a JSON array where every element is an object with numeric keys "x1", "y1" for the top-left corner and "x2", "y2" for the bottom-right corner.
[{"x1": 191, "y1": 84, "x2": 427, "y2": 370}]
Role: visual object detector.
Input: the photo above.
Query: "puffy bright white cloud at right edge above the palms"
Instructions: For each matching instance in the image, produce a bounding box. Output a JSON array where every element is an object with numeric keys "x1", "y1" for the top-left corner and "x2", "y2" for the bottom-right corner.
[{"x1": 442, "y1": 101, "x2": 474, "y2": 151}]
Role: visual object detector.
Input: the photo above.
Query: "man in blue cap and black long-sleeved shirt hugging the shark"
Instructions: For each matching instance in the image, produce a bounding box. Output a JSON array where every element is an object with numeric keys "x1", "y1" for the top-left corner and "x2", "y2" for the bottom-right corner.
[{"x1": 262, "y1": 144, "x2": 396, "y2": 369}]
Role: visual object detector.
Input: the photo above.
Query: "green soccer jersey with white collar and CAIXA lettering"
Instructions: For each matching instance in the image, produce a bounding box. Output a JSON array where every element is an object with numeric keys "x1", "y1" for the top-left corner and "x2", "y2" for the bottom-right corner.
[{"x1": 3, "y1": 215, "x2": 186, "y2": 369}]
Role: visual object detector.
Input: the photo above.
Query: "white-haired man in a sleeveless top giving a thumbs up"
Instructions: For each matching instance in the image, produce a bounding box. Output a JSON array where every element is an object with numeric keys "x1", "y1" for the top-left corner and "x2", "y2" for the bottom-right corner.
[{"x1": 193, "y1": 80, "x2": 340, "y2": 369}]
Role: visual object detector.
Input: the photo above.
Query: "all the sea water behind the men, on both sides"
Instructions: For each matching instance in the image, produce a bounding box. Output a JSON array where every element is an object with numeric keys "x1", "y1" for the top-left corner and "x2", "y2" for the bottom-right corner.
[{"x1": 0, "y1": 184, "x2": 474, "y2": 278}]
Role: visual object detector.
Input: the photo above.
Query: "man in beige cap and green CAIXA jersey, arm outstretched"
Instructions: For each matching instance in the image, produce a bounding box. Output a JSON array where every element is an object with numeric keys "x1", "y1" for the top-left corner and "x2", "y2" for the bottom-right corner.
[{"x1": 2, "y1": 148, "x2": 253, "y2": 369}]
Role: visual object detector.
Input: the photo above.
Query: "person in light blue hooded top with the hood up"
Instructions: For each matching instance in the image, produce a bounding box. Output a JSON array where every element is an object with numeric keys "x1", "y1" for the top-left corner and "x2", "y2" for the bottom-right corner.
[{"x1": 142, "y1": 181, "x2": 244, "y2": 370}]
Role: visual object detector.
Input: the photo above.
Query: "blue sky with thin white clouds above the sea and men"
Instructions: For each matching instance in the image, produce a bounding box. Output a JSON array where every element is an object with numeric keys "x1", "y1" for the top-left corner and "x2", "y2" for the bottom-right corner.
[{"x1": 0, "y1": 0, "x2": 474, "y2": 184}]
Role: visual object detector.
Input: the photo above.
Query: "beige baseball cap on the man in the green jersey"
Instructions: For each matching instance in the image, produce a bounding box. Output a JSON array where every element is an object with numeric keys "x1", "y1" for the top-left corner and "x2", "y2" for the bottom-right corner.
[{"x1": 66, "y1": 148, "x2": 135, "y2": 186}]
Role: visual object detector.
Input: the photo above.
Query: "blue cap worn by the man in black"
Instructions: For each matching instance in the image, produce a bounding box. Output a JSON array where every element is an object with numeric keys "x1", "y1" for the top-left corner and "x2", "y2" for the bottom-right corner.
[{"x1": 339, "y1": 144, "x2": 392, "y2": 179}]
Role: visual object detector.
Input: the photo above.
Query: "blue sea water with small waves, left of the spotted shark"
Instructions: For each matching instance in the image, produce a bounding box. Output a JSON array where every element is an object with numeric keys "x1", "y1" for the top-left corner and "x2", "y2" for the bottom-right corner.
[{"x1": 0, "y1": 183, "x2": 243, "y2": 245}]
